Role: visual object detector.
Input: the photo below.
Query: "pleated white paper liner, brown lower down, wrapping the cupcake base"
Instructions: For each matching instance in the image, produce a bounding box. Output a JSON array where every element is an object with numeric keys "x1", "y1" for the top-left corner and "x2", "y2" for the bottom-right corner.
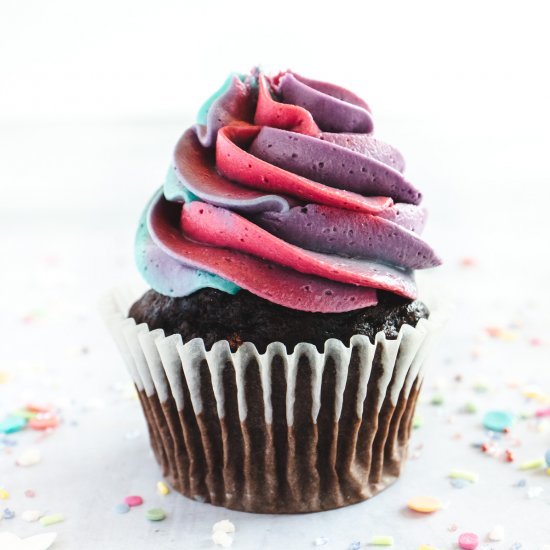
[{"x1": 102, "y1": 293, "x2": 442, "y2": 513}]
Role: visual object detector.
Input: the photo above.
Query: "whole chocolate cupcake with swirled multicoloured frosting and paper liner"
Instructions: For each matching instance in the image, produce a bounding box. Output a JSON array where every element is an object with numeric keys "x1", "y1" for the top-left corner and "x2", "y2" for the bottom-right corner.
[{"x1": 104, "y1": 70, "x2": 441, "y2": 513}]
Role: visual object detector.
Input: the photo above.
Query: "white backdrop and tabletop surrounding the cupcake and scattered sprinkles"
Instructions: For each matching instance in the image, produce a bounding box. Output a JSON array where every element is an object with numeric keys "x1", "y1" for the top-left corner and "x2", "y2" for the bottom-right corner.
[{"x1": 0, "y1": 0, "x2": 550, "y2": 550}]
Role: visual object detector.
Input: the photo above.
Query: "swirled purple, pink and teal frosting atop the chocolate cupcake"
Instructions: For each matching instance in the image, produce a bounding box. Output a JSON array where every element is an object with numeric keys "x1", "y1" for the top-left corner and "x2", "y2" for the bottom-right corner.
[{"x1": 136, "y1": 70, "x2": 440, "y2": 312}]
